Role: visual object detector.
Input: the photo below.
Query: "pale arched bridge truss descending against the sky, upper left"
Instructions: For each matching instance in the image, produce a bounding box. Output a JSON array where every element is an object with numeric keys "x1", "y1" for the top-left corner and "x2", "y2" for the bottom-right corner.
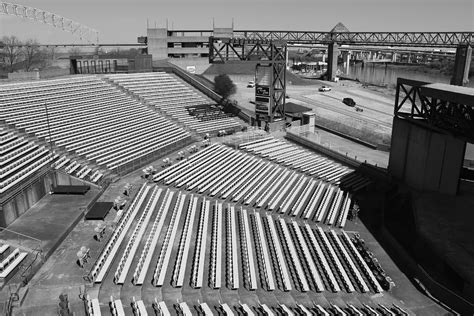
[{"x1": 0, "y1": 1, "x2": 99, "y2": 44}]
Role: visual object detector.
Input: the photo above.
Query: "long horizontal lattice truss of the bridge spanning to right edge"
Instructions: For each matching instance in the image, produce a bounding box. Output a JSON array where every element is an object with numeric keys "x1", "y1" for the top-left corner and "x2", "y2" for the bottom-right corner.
[{"x1": 234, "y1": 31, "x2": 474, "y2": 47}]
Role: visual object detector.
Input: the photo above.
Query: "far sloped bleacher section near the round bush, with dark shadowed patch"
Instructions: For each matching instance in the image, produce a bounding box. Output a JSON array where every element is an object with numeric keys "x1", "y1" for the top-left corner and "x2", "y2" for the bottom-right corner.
[{"x1": 108, "y1": 72, "x2": 242, "y2": 134}]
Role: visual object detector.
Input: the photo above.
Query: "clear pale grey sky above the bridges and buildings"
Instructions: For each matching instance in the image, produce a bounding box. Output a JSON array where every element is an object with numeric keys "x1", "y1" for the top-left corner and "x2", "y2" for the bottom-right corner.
[{"x1": 0, "y1": 0, "x2": 474, "y2": 44}]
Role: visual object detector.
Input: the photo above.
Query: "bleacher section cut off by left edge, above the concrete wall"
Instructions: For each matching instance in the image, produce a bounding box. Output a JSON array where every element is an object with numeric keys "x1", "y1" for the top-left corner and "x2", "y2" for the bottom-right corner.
[{"x1": 0, "y1": 127, "x2": 57, "y2": 193}]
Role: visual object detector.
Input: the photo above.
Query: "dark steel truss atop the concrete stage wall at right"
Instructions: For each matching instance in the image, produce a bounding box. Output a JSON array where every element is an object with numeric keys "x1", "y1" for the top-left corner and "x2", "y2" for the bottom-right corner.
[{"x1": 394, "y1": 78, "x2": 474, "y2": 142}]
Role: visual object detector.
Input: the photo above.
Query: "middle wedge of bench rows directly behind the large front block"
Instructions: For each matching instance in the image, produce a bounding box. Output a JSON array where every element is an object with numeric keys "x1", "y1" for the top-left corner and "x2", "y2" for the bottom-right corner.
[{"x1": 154, "y1": 144, "x2": 352, "y2": 227}]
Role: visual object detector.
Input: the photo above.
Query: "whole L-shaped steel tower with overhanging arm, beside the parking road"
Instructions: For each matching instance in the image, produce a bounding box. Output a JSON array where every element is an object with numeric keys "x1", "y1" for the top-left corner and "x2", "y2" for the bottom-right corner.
[{"x1": 209, "y1": 37, "x2": 287, "y2": 123}]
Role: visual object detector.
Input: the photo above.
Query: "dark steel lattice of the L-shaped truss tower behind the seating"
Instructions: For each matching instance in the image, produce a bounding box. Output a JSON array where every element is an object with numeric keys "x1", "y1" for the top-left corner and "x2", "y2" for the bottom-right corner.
[{"x1": 209, "y1": 37, "x2": 287, "y2": 122}]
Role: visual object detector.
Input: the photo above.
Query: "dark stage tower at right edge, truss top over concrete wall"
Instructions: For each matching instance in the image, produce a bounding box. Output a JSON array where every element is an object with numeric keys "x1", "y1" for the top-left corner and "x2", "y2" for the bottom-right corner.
[{"x1": 388, "y1": 78, "x2": 474, "y2": 195}]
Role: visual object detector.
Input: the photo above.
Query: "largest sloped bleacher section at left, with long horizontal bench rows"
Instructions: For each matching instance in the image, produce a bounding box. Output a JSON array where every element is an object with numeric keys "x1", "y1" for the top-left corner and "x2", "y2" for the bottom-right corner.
[{"x1": 0, "y1": 76, "x2": 190, "y2": 177}]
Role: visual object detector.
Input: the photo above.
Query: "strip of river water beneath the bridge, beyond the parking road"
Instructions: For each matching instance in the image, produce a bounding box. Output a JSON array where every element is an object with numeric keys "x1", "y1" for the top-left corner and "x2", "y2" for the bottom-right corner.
[{"x1": 339, "y1": 63, "x2": 474, "y2": 88}]
